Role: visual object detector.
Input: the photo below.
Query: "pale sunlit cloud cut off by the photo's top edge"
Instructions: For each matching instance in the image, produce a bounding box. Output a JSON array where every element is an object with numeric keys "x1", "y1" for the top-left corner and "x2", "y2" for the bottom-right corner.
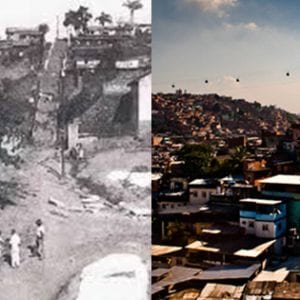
[{"x1": 184, "y1": 0, "x2": 238, "y2": 18}]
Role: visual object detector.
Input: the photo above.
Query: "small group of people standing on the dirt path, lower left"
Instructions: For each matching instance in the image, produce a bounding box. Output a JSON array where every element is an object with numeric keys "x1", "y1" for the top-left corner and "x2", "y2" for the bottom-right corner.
[{"x1": 0, "y1": 219, "x2": 45, "y2": 268}]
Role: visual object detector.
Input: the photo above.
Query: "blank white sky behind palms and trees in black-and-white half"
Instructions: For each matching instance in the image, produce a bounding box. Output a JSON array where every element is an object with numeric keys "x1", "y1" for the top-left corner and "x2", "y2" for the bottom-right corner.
[{"x1": 0, "y1": 0, "x2": 151, "y2": 39}]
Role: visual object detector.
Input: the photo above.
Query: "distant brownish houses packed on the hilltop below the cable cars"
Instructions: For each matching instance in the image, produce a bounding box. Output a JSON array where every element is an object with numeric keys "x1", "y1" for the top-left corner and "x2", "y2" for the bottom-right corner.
[{"x1": 152, "y1": 92, "x2": 288, "y2": 140}]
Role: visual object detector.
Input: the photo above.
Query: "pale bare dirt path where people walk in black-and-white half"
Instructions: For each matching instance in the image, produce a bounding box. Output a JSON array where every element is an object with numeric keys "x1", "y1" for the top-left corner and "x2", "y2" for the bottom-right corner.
[{"x1": 0, "y1": 151, "x2": 150, "y2": 300}]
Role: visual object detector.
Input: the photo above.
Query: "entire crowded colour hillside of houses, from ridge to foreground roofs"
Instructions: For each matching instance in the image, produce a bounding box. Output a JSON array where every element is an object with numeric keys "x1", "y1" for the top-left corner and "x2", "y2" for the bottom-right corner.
[{"x1": 151, "y1": 89, "x2": 300, "y2": 300}]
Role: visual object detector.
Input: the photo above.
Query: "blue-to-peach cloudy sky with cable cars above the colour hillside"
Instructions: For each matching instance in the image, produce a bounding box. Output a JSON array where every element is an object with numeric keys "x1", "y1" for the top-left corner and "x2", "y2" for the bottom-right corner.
[{"x1": 152, "y1": 0, "x2": 300, "y2": 113}]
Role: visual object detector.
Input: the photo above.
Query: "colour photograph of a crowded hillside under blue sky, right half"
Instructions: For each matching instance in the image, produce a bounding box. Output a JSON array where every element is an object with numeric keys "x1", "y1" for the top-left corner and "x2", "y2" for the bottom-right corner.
[{"x1": 151, "y1": 0, "x2": 300, "y2": 300}]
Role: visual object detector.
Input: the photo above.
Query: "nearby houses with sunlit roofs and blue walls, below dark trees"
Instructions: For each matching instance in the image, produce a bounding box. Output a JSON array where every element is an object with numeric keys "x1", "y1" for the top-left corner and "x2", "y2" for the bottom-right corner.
[{"x1": 152, "y1": 125, "x2": 300, "y2": 300}]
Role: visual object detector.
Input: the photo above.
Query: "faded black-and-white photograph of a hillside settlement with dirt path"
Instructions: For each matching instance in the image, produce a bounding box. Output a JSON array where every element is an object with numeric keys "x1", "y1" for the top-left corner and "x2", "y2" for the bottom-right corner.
[{"x1": 0, "y1": 0, "x2": 152, "y2": 300}]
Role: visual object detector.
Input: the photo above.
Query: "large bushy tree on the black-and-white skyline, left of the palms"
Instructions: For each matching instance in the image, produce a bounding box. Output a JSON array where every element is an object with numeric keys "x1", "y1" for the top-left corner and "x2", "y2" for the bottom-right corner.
[{"x1": 63, "y1": 6, "x2": 93, "y2": 34}]
